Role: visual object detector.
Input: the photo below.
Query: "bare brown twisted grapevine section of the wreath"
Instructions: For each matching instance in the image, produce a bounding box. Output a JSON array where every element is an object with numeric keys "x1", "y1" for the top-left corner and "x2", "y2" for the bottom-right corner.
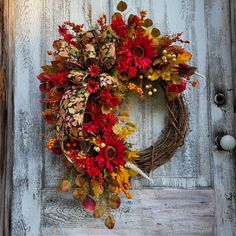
[{"x1": 136, "y1": 85, "x2": 189, "y2": 173}]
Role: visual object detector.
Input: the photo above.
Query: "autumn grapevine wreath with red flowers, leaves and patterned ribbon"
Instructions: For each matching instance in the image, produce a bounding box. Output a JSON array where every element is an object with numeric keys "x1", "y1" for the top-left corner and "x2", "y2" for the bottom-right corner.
[{"x1": 37, "y1": 1, "x2": 197, "y2": 229}]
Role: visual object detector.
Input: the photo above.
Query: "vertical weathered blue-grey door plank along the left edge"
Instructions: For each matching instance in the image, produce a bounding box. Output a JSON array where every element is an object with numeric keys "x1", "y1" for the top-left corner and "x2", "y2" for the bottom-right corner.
[{"x1": 11, "y1": 0, "x2": 43, "y2": 236}]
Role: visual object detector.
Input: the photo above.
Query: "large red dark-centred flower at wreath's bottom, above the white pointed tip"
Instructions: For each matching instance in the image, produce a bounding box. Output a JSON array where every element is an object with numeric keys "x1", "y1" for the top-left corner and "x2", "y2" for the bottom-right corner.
[{"x1": 95, "y1": 135, "x2": 126, "y2": 173}]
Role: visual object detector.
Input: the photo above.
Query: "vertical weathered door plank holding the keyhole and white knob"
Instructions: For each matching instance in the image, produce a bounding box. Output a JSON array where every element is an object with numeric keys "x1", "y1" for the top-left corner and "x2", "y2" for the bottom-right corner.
[{"x1": 205, "y1": 0, "x2": 236, "y2": 236}]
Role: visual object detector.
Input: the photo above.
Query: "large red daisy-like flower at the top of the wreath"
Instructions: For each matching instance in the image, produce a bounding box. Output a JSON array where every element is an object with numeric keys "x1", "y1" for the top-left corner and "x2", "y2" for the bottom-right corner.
[{"x1": 126, "y1": 32, "x2": 157, "y2": 69}]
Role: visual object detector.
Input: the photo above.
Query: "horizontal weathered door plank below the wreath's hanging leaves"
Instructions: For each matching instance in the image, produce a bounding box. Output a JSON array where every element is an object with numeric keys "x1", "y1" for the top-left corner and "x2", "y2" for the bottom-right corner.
[{"x1": 42, "y1": 189, "x2": 215, "y2": 236}]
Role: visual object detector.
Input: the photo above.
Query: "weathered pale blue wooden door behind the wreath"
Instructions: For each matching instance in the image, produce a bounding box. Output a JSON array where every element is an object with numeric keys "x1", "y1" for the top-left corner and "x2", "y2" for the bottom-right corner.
[{"x1": 0, "y1": 0, "x2": 236, "y2": 236}]
